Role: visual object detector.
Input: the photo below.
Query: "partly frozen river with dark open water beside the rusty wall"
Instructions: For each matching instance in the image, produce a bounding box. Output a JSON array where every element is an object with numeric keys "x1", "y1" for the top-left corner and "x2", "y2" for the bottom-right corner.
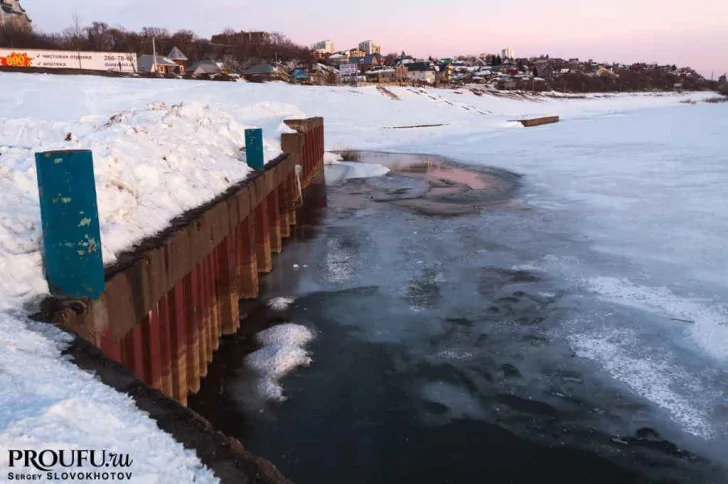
[{"x1": 192, "y1": 105, "x2": 728, "y2": 483}]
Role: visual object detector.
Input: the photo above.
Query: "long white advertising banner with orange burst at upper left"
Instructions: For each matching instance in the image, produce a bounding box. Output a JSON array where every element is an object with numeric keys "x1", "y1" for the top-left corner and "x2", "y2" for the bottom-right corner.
[{"x1": 0, "y1": 47, "x2": 137, "y2": 72}]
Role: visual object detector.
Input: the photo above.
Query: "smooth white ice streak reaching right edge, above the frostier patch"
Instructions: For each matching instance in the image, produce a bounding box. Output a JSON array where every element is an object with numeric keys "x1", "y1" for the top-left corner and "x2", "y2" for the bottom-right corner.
[{"x1": 587, "y1": 277, "x2": 728, "y2": 360}]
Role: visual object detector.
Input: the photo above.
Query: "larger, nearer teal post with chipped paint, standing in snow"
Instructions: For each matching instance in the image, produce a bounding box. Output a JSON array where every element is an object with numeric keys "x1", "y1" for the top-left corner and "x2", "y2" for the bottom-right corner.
[{"x1": 35, "y1": 150, "x2": 104, "y2": 299}]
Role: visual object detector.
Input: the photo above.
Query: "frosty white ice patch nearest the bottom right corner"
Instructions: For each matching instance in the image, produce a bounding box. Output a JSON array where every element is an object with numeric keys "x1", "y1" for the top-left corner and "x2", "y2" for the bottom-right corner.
[{"x1": 567, "y1": 331, "x2": 713, "y2": 439}]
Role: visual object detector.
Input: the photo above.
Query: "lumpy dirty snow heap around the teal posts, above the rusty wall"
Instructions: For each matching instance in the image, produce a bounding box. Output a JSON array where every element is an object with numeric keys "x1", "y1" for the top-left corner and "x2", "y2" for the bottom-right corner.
[{"x1": 0, "y1": 103, "x2": 281, "y2": 270}]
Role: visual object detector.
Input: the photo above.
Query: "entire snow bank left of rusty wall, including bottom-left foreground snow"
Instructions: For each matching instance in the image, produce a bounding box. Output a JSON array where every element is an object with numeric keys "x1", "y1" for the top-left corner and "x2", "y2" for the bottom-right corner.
[{"x1": 0, "y1": 76, "x2": 312, "y2": 483}]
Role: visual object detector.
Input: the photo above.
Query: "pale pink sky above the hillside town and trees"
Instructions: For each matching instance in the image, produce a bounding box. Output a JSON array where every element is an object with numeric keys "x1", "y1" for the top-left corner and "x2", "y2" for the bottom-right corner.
[{"x1": 21, "y1": 0, "x2": 728, "y2": 77}]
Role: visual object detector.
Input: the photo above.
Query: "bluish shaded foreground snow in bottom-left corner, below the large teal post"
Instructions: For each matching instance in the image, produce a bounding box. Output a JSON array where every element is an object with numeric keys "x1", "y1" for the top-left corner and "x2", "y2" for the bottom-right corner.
[{"x1": 0, "y1": 313, "x2": 218, "y2": 484}]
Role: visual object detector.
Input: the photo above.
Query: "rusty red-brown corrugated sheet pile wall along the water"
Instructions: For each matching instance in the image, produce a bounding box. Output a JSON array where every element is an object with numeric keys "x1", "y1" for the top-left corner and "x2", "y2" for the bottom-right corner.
[{"x1": 54, "y1": 118, "x2": 324, "y2": 403}]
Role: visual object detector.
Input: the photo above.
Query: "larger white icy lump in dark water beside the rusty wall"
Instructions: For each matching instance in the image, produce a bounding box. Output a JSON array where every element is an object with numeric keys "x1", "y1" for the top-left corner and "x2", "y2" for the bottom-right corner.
[{"x1": 245, "y1": 323, "x2": 313, "y2": 402}]
